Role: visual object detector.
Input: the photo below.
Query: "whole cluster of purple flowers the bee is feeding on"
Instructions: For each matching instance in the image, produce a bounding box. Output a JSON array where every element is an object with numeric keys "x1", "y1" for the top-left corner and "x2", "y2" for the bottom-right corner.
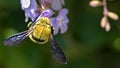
[{"x1": 21, "y1": 0, "x2": 69, "y2": 34}]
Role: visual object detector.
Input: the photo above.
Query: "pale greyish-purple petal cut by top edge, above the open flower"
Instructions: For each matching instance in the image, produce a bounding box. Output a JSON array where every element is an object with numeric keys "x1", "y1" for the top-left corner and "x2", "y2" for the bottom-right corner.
[{"x1": 51, "y1": 0, "x2": 65, "y2": 11}]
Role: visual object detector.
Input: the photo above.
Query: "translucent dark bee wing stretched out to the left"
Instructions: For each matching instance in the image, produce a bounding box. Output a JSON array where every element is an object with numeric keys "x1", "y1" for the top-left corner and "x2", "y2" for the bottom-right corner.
[{"x1": 4, "y1": 30, "x2": 31, "y2": 46}]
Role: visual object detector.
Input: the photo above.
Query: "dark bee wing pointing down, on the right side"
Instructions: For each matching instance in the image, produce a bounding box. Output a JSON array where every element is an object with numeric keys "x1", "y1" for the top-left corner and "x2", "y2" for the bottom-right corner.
[{"x1": 50, "y1": 35, "x2": 67, "y2": 64}]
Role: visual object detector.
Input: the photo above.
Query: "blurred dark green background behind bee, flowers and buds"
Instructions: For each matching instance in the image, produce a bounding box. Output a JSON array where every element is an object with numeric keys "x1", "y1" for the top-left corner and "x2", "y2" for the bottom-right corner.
[{"x1": 0, "y1": 0, "x2": 120, "y2": 68}]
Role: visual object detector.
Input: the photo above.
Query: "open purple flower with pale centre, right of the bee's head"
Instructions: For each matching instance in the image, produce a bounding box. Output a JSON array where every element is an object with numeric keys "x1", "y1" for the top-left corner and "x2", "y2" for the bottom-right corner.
[{"x1": 51, "y1": 8, "x2": 69, "y2": 34}]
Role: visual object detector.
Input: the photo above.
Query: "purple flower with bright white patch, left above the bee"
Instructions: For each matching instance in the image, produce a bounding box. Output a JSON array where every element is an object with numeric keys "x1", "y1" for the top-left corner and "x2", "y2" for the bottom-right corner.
[{"x1": 20, "y1": 0, "x2": 38, "y2": 22}]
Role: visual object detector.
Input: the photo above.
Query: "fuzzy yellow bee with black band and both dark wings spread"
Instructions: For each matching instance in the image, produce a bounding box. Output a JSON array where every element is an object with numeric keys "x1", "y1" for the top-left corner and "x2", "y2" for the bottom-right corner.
[{"x1": 4, "y1": 17, "x2": 67, "y2": 64}]
